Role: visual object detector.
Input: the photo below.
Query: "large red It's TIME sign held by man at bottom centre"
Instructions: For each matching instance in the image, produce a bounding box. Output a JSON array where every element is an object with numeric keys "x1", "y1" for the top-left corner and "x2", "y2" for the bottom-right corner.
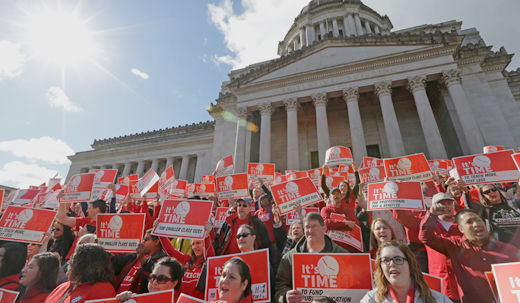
[{"x1": 292, "y1": 253, "x2": 372, "y2": 302}]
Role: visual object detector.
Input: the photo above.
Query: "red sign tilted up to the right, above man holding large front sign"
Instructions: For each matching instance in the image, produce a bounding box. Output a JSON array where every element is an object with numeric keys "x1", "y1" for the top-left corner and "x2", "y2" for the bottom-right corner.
[{"x1": 271, "y1": 178, "x2": 322, "y2": 215}]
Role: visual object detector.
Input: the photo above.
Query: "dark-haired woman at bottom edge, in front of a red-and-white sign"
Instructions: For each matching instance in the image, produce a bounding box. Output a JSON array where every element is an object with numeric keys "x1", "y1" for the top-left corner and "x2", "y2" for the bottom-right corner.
[{"x1": 212, "y1": 257, "x2": 253, "y2": 303}]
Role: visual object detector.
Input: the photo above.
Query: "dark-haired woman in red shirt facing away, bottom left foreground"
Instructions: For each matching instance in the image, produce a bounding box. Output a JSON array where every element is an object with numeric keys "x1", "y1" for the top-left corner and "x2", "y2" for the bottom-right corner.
[{"x1": 45, "y1": 243, "x2": 116, "y2": 303}]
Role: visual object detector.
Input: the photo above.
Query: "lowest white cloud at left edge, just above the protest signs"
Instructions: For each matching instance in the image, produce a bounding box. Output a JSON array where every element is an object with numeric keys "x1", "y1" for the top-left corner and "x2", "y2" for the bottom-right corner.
[{"x1": 0, "y1": 161, "x2": 57, "y2": 188}]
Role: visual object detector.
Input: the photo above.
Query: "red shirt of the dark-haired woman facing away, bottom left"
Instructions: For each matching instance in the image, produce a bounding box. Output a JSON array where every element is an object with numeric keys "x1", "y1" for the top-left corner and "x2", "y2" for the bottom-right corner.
[{"x1": 45, "y1": 281, "x2": 116, "y2": 303}]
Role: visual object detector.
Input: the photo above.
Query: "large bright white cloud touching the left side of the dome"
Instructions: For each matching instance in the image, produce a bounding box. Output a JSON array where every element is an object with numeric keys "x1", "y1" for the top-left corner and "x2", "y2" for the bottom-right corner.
[{"x1": 208, "y1": 0, "x2": 309, "y2": 68}]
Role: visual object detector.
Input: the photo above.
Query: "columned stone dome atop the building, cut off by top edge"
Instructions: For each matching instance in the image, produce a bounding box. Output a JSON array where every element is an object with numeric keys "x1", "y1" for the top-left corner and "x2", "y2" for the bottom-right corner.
[{"x1": 278, "y1": 0, "x2": 393, "y2": 56}]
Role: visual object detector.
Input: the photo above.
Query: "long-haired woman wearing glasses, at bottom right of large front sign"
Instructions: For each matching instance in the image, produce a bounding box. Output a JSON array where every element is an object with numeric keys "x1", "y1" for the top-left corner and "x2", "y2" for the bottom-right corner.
[{"x1": 361, "y1": 241, "x2": 451, "y2": 303}]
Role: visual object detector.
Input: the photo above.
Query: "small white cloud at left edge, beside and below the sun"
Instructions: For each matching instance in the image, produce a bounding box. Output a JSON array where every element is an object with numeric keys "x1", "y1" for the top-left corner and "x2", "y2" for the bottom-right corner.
[{"x1": 0, "y1": 40, "x2": 26, "y2": 80}]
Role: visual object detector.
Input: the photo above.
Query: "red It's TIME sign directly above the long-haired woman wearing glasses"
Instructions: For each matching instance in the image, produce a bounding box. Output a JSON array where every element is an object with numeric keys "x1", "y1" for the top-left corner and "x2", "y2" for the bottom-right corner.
[{"x1": 367, "y1": 182, "x2": 425, "y2": 211}]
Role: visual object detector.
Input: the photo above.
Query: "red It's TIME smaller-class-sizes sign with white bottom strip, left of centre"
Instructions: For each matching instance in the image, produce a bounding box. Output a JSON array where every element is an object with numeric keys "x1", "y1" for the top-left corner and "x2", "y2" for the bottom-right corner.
[{"x1": 152, "y1": 199, "x2": 213, "y2": 240}]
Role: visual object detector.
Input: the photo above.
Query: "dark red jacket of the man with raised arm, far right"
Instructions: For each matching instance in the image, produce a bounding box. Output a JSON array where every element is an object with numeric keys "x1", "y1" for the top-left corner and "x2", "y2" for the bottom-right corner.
[{"x1": 419, "y1": 213, "x2": 518, "y2": 303}]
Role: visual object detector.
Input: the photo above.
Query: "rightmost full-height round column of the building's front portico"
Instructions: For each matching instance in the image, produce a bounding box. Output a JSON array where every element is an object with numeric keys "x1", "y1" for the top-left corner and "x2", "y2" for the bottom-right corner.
[{"x1": 442, "y1": 69, "x2": 485, "y2": 154}]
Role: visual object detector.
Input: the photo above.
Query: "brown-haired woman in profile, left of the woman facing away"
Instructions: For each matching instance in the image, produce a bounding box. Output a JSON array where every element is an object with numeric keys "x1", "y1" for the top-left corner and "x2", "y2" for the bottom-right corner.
[{"x1": 17, "y1": 252, "x2": 60, "y2": 303}]
